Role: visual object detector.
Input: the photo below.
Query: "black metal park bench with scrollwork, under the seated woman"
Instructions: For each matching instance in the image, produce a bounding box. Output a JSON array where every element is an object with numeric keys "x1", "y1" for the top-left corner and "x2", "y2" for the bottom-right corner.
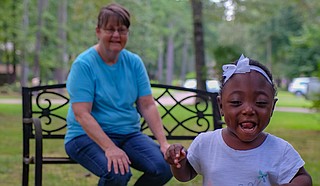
[{"x1": 22, "y1": 84, "x2": 223, "y2": 186}]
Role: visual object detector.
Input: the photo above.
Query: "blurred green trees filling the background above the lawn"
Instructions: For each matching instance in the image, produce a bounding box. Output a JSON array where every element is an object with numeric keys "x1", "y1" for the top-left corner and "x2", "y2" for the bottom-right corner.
[{"x1": 0, "y1": 0, "x2": 320, "y2": 89}]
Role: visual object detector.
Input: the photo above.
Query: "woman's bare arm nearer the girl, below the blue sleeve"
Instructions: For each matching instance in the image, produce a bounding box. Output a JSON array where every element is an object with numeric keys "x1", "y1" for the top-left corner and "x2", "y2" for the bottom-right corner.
[{"x1": 137, "y1": 95, "x2": 169, "y2": 154}]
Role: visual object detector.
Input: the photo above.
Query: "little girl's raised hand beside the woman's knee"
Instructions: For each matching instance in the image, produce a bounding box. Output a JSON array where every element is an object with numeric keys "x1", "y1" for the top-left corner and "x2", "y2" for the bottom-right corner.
[{"x1": 165, "y1": 144, "x2": 187, "y2": 168}]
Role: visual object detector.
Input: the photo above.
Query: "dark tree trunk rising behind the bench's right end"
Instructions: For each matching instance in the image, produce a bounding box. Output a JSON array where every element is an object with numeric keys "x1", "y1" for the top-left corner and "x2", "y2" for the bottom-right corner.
[{"x1": 191, "y1": 0, "x2": 206, "y2": 90}]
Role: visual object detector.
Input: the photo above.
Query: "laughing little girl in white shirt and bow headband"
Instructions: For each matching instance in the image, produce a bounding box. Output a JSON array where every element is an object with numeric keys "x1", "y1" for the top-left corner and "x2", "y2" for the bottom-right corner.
[{"x1": 165, "y1": 55, "x2": 312, "y2": 186}]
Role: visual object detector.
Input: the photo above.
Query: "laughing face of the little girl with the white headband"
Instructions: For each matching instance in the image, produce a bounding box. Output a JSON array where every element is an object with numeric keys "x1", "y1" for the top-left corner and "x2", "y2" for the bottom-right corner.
[{"x1": 218, "y1": 70, "x2": 277, "y2": 147}]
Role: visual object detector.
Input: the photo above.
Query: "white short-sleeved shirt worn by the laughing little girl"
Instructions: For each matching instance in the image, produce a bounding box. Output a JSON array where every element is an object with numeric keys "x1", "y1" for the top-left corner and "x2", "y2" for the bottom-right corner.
[{"x1": 187, "y1": 129, "x2": 305, "y2": 186}]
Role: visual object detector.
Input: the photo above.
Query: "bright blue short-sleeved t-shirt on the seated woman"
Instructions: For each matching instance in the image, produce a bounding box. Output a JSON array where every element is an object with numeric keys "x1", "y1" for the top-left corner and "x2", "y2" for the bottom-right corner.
[{"x1": 65, "y1": 47, "x2": 151, "y2": 143}]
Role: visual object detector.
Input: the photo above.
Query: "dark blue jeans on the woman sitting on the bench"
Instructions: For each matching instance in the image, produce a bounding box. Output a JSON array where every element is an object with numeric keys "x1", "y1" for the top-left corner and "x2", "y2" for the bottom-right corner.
[{"x1": 65, "y1": 132, "x2": 172, "y2": 186}]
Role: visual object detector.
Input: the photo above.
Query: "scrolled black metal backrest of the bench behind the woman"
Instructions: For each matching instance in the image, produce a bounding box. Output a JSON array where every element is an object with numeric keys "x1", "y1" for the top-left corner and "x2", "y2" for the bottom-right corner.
[{"x1": 22, "y1": 84, "x2": 223, "y2": 141}]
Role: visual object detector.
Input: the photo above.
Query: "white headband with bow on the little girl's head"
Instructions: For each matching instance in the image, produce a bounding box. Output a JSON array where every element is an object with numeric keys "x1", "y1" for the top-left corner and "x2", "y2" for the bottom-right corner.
[{"x1": 222, "y1": 54, "x2": 272, "y2": 84}]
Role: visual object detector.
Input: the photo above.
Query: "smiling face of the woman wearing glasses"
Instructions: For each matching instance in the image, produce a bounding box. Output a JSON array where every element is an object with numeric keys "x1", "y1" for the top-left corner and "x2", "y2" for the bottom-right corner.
[{"x1": 96, "y1": 17, "x2": 129, "y2": 53}]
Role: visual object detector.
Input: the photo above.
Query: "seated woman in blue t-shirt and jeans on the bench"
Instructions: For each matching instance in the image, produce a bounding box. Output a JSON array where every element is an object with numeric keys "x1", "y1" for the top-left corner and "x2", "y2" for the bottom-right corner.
[{"x1": 65, "y1": 4, "x2": 172, "y2": 185}]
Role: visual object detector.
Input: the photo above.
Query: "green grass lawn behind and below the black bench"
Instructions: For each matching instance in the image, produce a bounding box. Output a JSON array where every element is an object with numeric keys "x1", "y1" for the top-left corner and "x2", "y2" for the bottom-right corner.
[{"x1": 0, "y1": 92, "x2": 320, "y2": 186}]
